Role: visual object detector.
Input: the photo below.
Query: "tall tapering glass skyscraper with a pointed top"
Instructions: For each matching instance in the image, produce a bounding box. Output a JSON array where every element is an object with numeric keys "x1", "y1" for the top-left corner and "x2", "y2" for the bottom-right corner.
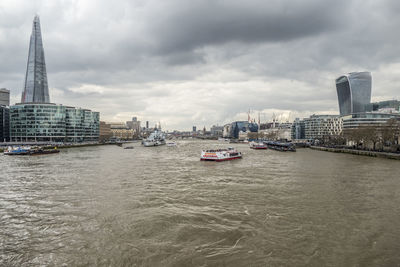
[{"x1": 21, "y1": 16, "x2": 50, "y2": 103}]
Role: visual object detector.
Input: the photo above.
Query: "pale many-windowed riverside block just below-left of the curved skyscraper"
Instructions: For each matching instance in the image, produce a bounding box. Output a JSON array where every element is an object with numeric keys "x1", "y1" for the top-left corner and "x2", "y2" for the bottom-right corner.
[{"x1": 304, "y1": 115, "x2": 343, "y2": 140}]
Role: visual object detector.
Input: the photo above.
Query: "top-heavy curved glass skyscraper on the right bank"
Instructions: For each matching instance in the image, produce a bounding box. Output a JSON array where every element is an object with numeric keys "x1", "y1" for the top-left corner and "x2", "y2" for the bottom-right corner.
[{"x1": 336, "y1": 72, "x2": 372, "y2": 116}]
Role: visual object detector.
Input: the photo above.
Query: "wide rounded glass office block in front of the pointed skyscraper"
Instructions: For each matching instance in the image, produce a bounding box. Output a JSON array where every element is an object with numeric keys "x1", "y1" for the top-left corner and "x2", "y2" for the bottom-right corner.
[{"x1": 10, "y1": 103, "x2": 99, "y2": 142}]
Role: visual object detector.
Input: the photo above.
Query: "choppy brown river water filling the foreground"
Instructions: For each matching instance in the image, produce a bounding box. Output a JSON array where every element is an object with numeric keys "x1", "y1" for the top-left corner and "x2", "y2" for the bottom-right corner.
[{"x1": 0, "y1": 141, "x2": 400, "y2": 266}]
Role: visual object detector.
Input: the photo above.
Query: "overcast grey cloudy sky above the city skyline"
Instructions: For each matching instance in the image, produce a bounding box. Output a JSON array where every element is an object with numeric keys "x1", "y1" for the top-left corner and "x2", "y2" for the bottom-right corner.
[{"x1": 0, "y1": 0, "x2": 400, "y2": 130}]
